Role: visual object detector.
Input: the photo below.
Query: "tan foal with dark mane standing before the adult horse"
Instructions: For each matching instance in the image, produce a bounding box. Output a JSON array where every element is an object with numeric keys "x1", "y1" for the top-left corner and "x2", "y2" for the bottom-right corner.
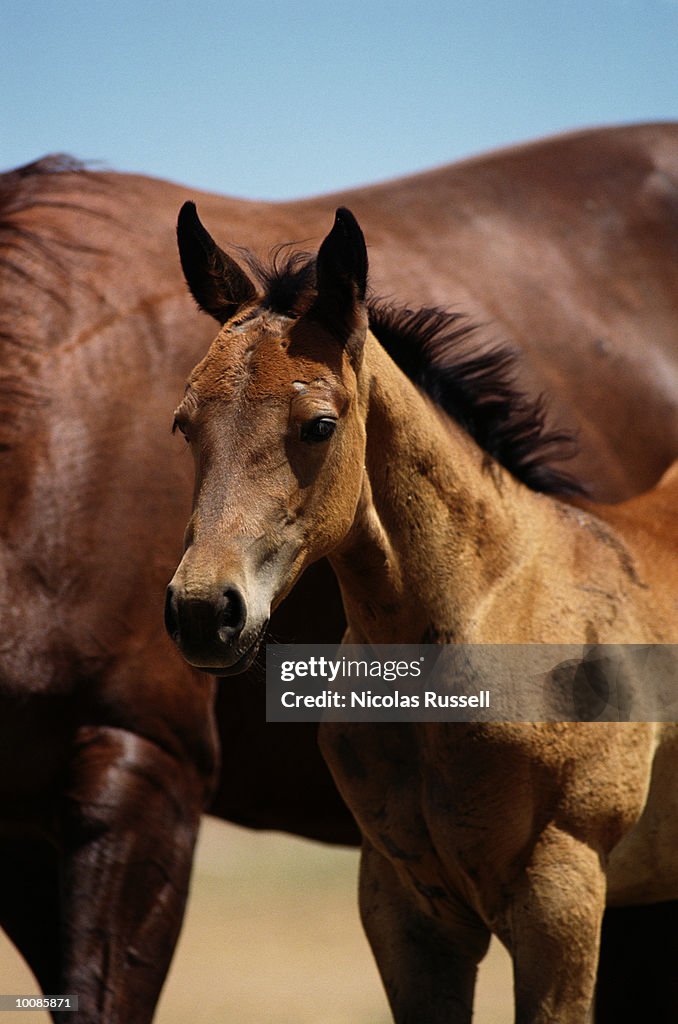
[{"x1": 166, "y1": 203, "x2": 678, "y2": 1024}]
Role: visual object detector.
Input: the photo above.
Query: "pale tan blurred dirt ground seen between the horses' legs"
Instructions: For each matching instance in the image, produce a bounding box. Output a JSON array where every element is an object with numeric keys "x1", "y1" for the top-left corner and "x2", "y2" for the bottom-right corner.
[{"x1": 0, "y1": 819, "x2": 513, "y2": 1024}]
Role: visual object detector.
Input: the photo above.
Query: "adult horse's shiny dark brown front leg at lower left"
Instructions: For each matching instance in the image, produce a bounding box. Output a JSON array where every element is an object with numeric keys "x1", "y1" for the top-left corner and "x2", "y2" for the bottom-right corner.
[{"x1": 56, "y1": 726, "x2": 205, "y2": 1024}]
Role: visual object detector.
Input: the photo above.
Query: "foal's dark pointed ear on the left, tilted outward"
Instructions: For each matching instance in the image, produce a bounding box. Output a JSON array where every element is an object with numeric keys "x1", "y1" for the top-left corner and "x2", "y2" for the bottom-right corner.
[{"x1": 176, "y1": 203, "x2": 257, "y2": 324}]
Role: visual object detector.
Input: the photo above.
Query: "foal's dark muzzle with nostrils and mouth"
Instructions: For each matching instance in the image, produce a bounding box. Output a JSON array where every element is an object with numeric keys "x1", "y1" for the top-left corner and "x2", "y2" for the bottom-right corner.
[{"x1": 165, "y1": 583, "x2": 258, "y2": 672}]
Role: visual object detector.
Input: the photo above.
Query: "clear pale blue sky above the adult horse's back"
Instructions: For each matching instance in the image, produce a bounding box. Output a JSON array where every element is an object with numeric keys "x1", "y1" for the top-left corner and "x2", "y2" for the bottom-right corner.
[{"x1": 0, "y1": 0, "x2": 678, "y2": 199}]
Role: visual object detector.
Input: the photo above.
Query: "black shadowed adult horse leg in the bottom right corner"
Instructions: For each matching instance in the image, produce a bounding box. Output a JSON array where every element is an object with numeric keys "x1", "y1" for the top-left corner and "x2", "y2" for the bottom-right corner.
[{"x1": 596, "y1": 901, "x2": 678, "y2": 1024}]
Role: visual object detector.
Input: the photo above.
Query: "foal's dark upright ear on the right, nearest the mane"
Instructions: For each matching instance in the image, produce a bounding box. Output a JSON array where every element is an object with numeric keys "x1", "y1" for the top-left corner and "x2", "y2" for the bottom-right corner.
[{"x1": 306, "y1": 207, "x2": 368, "y2": 354}]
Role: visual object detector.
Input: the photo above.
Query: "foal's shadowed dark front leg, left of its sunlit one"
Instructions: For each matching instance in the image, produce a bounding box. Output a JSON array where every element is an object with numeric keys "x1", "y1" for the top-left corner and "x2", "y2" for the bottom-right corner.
[{"x1": 359, "y1": 840, "x2": 490, "y2": 1024}]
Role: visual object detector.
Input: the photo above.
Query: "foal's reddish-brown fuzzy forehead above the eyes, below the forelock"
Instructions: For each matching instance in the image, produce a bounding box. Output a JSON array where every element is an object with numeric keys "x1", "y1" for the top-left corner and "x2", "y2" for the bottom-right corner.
[{"x1": 188, "y1": 312, "x2": 350, "y2": 401}]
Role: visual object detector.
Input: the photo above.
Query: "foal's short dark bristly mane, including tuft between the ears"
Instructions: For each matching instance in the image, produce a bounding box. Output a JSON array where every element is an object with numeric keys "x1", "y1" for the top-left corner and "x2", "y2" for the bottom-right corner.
[{"x1": 238, "y1": 246, "x2": 586, "y2": 495}]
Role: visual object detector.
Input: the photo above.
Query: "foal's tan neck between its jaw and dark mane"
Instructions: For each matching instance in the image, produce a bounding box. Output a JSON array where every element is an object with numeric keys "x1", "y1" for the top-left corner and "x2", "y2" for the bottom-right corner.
[{"x1": 331, "y1": 336, "x2": 548, "y2": 643}]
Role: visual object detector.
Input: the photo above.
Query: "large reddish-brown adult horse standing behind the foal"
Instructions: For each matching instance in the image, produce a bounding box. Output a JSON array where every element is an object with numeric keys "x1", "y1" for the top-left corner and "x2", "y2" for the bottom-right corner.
[{"x1": 0, "y1": 125, "x2": 678, "y2": 1022}]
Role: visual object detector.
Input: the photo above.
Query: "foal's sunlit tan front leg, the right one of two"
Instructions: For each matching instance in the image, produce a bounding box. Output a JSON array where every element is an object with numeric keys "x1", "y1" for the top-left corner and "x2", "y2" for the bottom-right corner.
[{"x1": 497, "y1": 825, "x2": 605, "y2": 1024}]
